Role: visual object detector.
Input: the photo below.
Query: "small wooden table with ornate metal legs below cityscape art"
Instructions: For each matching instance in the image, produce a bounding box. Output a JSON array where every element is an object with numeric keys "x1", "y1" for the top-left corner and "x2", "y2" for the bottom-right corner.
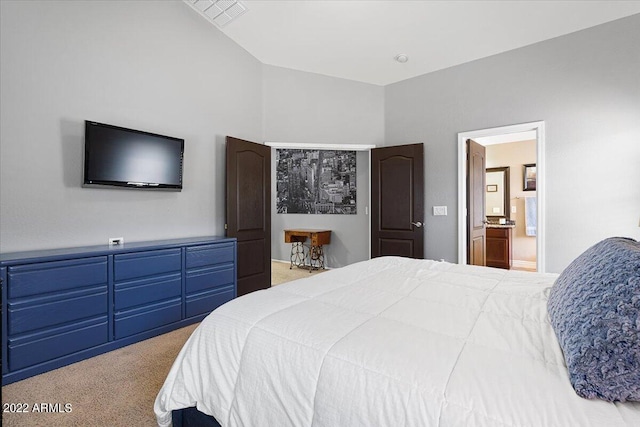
[{"x1": 284, "y1": 228, "x2": 331, "y2": 273}]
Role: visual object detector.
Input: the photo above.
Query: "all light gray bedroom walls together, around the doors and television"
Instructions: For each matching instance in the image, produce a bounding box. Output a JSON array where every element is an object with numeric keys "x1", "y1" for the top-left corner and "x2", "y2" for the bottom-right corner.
[{"x1": 0, "y1": 1, "x2": 640, "y2": 271}]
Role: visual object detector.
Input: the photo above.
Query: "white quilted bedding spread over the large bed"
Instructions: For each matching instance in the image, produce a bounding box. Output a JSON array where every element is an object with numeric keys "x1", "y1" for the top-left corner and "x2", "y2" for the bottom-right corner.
[{"x1": 154, "y1": 257, "x2": 640, "y2": 427}]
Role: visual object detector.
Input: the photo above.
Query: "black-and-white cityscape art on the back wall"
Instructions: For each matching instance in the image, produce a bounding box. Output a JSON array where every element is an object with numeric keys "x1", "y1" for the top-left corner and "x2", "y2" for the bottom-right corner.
[{"x1": 276, "y1": 149, "x2": 357, "y2": 215}]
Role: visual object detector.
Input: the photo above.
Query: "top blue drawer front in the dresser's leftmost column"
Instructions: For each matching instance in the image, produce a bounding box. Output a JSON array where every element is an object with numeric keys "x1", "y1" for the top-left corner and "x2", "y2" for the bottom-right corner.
[{"x1": 7, "y1": 257, "x2": 107, "y2": 298}]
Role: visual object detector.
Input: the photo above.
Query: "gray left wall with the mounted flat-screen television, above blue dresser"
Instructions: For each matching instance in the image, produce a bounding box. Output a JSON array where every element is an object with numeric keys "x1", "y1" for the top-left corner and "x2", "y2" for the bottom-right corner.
[{"x1": 0, "y1": 1, "x2": 263, "y2": 252}]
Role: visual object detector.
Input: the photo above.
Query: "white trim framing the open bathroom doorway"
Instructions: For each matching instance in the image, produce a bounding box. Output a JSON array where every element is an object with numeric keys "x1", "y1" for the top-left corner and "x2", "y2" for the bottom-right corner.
[{"x1": 458, "y1": 121, "x2": 546, "y2": 272}]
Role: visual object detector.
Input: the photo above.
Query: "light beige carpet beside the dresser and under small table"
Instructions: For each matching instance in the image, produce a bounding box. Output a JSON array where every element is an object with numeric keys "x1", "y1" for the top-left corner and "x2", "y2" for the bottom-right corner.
[{"x1": 2, "y1": 262, "x2": 319, "y2": 427}]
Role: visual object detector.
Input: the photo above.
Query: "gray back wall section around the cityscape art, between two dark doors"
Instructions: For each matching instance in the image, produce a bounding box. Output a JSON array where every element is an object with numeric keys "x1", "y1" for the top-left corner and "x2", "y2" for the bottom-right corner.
[{"x1": 263, "y1": 66, "x2": 384, "y2": 267}]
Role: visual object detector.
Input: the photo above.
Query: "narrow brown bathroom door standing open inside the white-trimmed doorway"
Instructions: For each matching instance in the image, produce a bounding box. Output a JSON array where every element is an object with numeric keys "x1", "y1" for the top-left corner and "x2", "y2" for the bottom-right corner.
[{"x1": 467, "y1": 139, "x2": 487, "y2": 265}]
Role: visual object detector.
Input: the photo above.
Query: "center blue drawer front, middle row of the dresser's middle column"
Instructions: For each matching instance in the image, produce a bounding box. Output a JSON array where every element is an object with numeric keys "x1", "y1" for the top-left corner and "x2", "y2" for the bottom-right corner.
[{"x1": 115, "y1": 274, "x2": 182, "y2": 310}]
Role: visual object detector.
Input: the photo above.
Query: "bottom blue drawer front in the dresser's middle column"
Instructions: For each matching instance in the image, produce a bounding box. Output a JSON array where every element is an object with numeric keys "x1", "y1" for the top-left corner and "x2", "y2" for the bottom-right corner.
[{"x1": 115, "y1": 298, "x2": 182, "y2": 339}]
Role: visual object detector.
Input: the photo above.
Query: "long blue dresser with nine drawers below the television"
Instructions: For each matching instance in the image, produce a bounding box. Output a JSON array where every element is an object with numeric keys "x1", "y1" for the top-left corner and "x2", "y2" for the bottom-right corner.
[{"x1": 0, "y1": 237, "x2": 237, "y2": 385}]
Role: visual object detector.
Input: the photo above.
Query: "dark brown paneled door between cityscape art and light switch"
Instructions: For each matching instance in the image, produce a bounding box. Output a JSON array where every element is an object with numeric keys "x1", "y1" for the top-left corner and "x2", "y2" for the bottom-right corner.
[{"x1": 371, "y1": 144, "x2": 424, "y2": 258}]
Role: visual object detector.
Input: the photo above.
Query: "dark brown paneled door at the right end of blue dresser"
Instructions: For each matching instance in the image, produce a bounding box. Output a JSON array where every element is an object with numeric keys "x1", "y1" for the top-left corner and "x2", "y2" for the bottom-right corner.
[{"x1": 226, "y1": 136, "x2": 271, "y2": 296}]
